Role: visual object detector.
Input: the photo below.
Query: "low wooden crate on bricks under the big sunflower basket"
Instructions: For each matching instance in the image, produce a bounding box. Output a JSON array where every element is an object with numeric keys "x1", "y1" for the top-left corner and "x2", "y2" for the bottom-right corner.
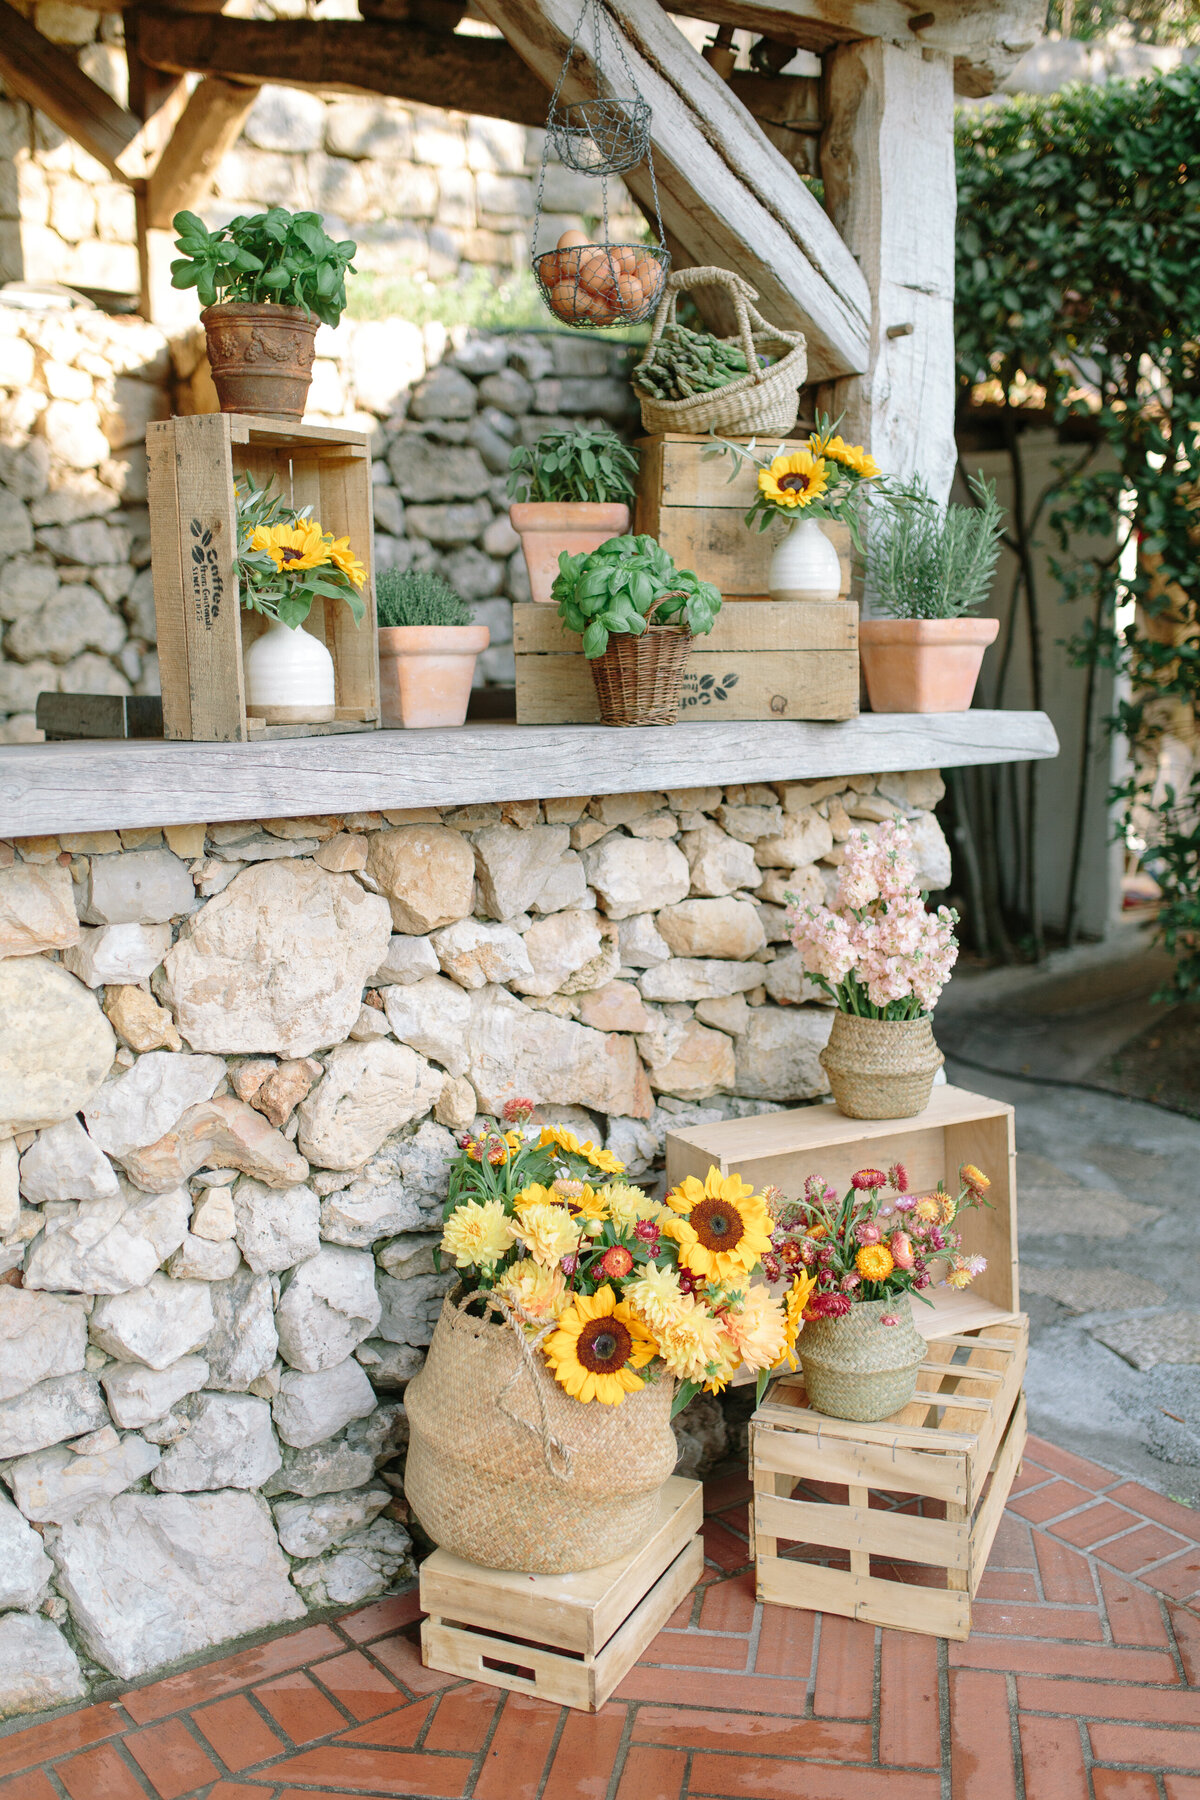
[{"x1": 421, "y1": 1476, "x2": 703, "y2": 1712}]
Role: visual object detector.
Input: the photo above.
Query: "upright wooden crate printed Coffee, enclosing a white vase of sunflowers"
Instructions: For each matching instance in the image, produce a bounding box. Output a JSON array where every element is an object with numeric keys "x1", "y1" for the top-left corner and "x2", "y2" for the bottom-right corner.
[{"x1": 146, "y1": 412, "x2": 380, "y2": 743}]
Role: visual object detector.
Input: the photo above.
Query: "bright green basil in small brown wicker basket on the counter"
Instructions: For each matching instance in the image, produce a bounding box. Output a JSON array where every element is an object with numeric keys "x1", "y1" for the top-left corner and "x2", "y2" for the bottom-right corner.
[{"x1": 552, "y1": 536, "x2": 721, "y2": 725}]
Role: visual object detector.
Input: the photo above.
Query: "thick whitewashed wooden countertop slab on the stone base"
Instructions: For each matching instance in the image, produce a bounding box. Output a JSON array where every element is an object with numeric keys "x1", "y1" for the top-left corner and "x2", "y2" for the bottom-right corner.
[{"x1": 0, "y1": 711, "x2": 1058, "y2": 837}]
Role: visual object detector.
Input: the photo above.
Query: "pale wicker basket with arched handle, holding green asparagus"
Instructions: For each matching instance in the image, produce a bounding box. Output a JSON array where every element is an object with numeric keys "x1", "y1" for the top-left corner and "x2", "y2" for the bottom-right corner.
[{"x1": 633, "y1": 268, "x2": 808, "y2": 436}]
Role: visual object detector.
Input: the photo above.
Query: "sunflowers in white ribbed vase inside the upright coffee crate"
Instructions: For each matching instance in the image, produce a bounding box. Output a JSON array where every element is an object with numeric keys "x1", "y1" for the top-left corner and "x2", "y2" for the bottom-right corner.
[{"x1": 236, "y1": 475, "x2": 367, "y2": 725}]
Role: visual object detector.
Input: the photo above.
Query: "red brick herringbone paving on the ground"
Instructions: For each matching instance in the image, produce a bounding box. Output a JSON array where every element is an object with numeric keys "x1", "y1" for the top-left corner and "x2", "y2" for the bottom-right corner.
[{"x1": 0, "y1": 1440, "x2": 1200, "y2": 1800}]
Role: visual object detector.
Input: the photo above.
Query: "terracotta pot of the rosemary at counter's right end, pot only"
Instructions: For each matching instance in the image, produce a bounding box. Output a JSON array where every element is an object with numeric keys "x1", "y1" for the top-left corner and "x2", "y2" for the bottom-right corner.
[{"x1": 858, "y1": 619, "x2": 1000, "y2": 713}]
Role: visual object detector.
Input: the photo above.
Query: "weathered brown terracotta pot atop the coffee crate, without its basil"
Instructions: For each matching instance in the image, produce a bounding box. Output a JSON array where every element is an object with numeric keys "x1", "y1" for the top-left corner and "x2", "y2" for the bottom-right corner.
[{"x1": 200, "y1": 301, "x2": 318, "y2": 419}]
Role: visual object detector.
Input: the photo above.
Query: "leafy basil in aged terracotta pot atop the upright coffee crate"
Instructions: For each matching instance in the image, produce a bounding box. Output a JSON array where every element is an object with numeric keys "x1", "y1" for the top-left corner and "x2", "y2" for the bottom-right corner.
[{"x1": 171, "y1": 207, "x2": 356, "y2": 419}]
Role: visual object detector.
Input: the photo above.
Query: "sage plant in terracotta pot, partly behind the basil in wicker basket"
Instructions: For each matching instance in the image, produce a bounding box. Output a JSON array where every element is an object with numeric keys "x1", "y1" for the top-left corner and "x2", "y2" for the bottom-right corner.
[{"x1": 509, "y1": 425, "x2": 637, "y2": 607}]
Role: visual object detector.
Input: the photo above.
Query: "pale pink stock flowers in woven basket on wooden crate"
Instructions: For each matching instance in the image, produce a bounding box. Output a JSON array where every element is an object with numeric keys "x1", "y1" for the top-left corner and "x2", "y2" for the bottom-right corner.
[{"x1": 788, "y1": 819, "x2": 959, "y2": 1120}]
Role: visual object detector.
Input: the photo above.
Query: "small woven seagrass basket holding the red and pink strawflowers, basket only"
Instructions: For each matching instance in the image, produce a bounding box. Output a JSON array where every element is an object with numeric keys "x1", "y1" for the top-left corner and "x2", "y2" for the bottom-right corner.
[{"x1": 797, "y1": 1294, "x2": 925, "y2": 1422}]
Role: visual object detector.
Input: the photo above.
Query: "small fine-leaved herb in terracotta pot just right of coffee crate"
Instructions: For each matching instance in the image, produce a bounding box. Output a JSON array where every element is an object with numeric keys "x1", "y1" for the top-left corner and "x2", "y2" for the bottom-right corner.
[{"x1": 374, "y1": 569, "x2": 491, "y2": 729}]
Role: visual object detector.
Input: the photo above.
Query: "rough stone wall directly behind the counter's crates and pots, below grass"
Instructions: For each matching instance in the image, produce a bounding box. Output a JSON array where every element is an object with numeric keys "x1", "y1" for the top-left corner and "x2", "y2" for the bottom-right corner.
[{"x1": 0, "y1": 306, "x2": 635, "y2": 743}]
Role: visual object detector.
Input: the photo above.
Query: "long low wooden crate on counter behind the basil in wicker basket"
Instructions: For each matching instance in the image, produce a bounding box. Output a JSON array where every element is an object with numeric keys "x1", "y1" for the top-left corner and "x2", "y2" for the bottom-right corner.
[{"x1": 513, "y1": 599, "x2": 858, "y2": 725}]
